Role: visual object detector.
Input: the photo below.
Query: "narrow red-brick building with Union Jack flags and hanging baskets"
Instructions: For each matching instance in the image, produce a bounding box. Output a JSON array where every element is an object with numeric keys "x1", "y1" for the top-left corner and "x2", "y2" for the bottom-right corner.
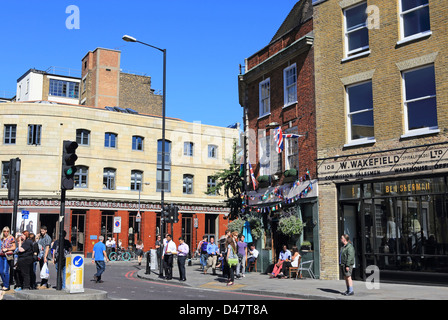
[{"x1": 239, "y1": 0, "x2": 319, "y2": 274}]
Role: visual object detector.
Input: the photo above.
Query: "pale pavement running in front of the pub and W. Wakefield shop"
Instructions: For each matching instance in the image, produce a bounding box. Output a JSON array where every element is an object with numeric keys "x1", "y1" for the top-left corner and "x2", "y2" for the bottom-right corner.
[{"x1": 137, "y1": 261, "x2": 448, "y2": 300}]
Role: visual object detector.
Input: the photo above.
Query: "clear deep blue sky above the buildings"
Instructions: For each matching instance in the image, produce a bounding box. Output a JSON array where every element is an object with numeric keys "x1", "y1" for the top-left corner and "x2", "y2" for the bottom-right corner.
[{"x1": 0, "y1": 0, "x2": 297, "y2": 126}]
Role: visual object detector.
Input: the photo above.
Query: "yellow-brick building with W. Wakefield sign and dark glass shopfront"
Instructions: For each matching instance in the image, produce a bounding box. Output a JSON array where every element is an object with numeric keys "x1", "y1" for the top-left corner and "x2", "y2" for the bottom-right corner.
[{"x1": 313, "y1": 0, "x2": 448, "y2": 283}]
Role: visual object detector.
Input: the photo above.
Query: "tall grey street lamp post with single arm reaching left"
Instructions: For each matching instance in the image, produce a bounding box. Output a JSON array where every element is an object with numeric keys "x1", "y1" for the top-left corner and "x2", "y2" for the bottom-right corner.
[{"x1": 122, "y1": 35, "x2": 166, "y2": 277}]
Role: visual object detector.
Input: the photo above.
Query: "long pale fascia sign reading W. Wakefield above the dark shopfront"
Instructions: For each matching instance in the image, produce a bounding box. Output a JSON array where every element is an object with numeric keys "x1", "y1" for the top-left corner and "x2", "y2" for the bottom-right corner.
[{"x1": 317, "y1": 146, "x2": 448, "y2": 181}]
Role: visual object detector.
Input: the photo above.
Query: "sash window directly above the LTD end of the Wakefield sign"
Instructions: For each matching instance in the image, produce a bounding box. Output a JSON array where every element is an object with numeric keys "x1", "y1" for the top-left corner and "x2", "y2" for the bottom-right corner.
[{"x1": 402, "y1": 65, "x2": 438, "y2": 133}]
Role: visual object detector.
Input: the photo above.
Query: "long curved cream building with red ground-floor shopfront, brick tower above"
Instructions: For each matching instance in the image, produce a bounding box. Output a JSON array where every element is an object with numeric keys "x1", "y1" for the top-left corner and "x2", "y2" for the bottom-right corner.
[{"x1": 0, "y1": 49, "x2": 239, "y2": 255}]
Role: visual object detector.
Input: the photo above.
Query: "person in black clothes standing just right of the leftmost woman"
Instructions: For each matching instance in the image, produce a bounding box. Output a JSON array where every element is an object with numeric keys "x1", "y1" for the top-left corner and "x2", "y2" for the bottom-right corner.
[{"x1": 16, "y1": 231, "x2": 33, "y2": 291}]
